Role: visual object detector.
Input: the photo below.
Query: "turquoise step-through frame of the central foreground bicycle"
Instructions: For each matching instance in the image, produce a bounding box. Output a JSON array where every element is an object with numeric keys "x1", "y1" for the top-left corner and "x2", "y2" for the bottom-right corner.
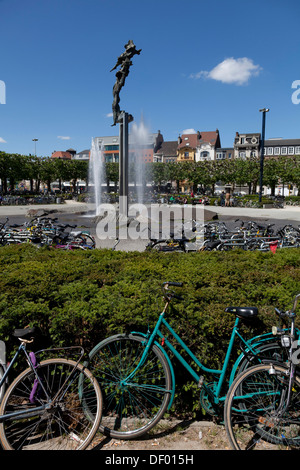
[{"x1": 129, "y1": 302, "x2": 282, "y2": 408}]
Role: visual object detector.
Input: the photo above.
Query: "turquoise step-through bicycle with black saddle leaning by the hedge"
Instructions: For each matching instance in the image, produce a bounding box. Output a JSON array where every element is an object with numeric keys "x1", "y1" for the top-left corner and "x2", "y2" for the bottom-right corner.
[{"x1": 89, "y1": 282, "x2": 294, "y2": 439}]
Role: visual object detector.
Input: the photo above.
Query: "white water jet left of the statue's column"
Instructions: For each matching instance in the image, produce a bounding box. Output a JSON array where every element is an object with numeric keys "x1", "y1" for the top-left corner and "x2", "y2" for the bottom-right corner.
[{"x1": 89, "y1": 139, "x2": 105, "y2": 215}]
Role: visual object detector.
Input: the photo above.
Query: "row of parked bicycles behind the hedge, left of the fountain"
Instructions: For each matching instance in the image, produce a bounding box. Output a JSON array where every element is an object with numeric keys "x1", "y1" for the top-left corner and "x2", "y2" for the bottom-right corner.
[{"x1": 0, "y1": 216, "x2": 96, "y2": 250}]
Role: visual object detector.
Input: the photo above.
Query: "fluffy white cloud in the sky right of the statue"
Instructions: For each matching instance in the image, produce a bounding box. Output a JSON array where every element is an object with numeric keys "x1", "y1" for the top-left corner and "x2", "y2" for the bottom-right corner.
[{"x1": 190, "y1": 57, "x2": 262, "y2": 85}]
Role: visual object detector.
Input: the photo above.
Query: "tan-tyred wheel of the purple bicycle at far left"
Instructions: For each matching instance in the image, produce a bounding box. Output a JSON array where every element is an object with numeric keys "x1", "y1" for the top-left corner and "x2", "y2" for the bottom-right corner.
[{"x1": 0, "y1": 359, "x2": 102, "y2": 450}]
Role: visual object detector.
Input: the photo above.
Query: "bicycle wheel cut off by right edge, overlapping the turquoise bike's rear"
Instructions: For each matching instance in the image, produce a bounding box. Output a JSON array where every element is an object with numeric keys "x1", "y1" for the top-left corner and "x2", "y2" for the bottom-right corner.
[{"x1": 224, "y1": 364, "x2": 300, "y2": 450}]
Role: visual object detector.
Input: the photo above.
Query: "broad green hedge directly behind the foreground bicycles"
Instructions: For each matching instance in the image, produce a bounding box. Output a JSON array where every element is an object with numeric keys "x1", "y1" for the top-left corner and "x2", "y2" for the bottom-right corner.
[{"x1": 0, "y1": 245, "x2": 300, "y2": 412}]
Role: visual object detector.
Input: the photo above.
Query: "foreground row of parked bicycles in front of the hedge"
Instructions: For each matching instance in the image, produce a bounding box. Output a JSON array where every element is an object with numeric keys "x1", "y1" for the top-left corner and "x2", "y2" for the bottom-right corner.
[{"x1": 0, "y1": 281, "x2": 300, "y2": 450}]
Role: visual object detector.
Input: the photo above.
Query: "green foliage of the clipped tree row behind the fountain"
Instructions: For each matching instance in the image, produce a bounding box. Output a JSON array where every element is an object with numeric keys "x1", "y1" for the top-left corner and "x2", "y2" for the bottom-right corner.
[{"x1": 0, "y1": 152, "x2": 300, "y2": 194}]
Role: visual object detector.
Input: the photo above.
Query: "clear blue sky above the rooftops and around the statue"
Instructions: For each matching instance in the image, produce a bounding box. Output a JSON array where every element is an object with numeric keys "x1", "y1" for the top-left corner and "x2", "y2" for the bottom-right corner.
[{"x1": 0, "y1": 0, "x2": 300, "y2": 156}]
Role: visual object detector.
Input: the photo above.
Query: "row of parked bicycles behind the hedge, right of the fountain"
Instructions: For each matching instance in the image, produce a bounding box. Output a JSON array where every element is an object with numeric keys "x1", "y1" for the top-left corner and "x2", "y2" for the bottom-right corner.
[{"x1": 146, "y1": 219, "x2": 300, "y2": 252}]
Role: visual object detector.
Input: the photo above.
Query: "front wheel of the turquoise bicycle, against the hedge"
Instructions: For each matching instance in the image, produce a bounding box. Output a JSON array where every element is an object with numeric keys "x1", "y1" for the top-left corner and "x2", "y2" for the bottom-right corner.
[{"x1": 89, "y1": 335, "x2": 171, "y2": 439}]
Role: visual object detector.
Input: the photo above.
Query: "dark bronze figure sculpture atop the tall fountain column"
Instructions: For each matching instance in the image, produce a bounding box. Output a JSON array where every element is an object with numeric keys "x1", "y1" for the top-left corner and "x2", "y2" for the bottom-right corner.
[{"x1": 111, "y1": 39, "x2": 142, "y2": 126}]
